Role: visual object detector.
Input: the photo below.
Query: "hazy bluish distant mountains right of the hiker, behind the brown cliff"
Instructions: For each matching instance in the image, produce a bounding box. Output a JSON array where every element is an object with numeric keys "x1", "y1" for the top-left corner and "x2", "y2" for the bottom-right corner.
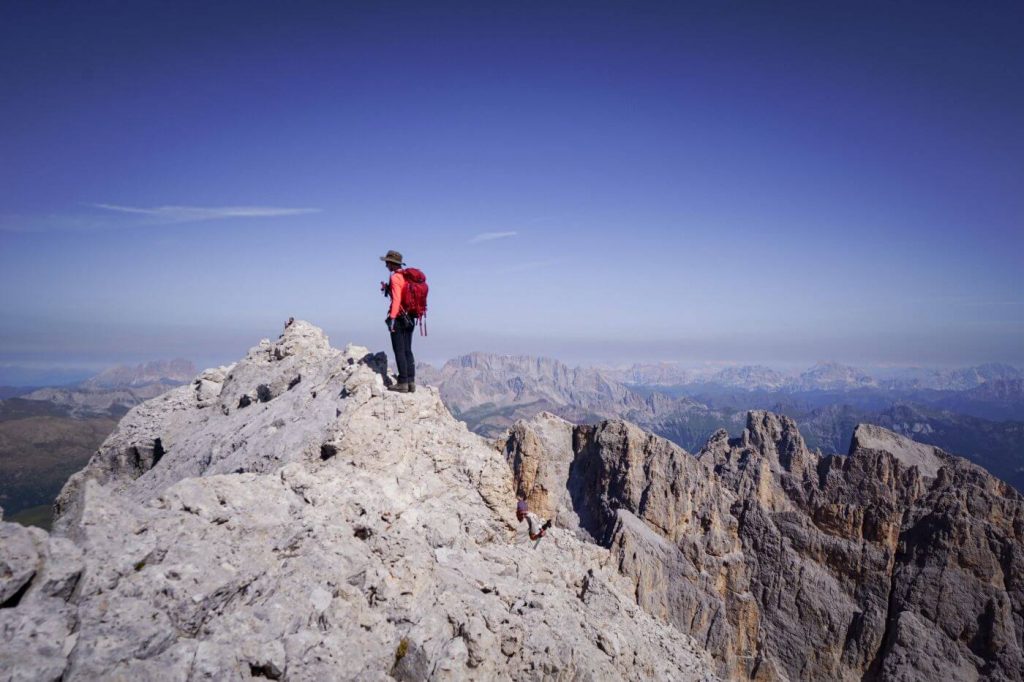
[{"x1": 417, "y1": 353, "x2": 1024, "y2": 489}]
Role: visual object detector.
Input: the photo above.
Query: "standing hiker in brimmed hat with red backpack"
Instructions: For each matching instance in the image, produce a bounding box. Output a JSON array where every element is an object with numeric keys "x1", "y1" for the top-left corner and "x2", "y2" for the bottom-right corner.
[{"x1": 381, "y1": 246, "x2": 427, "y2": 393}]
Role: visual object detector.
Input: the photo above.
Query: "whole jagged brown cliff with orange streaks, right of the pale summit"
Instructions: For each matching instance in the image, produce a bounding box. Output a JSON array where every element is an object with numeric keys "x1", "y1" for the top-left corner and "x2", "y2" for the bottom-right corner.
[{"x1": 499, "y1": 405, "x2": 1024, "y2": 680}]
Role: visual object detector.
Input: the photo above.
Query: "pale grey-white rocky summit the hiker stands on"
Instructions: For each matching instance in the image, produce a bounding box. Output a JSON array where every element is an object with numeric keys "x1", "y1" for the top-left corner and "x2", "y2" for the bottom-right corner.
[{"x1": 0, "y1": 322, "x2": 712, "y2": 680}]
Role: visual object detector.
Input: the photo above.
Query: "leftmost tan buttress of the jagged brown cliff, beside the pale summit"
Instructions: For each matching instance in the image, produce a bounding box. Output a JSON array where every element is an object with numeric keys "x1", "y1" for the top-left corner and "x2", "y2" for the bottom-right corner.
[{"x1": 498, "y1": 416, "x2": 757, "y2": 676}]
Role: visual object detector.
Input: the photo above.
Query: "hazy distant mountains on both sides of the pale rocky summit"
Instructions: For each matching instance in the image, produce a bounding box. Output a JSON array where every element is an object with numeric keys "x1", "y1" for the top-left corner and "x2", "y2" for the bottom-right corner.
[{"x1": 8, "y1": 353, "x2": 1024, "y2": 522}]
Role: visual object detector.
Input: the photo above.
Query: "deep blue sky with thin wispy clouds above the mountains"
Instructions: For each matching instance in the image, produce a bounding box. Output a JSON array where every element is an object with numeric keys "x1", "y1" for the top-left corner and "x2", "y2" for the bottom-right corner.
[{"x1": 0, "y1": 0, "x2": 1024, "y2": 376}]
